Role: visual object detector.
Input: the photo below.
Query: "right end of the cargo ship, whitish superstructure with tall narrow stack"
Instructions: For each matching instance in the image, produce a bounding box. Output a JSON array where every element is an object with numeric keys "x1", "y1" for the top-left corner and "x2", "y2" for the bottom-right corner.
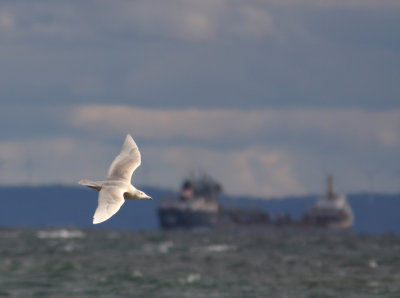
[{"x1": 303, "y1": 175, "x2": 354, "y2": 229}]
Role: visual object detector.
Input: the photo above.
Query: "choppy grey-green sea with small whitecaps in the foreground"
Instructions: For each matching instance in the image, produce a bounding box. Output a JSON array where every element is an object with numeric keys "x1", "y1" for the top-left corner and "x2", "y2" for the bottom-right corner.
[{"x1": 0, "y1": 228, "x2": 400, "y2": 298}]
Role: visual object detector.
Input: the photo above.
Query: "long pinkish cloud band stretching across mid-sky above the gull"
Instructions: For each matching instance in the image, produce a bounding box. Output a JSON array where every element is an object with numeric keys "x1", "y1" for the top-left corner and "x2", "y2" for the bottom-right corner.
[{"x1": 70, "y1": 105, "x2": 400, "y2": 148}]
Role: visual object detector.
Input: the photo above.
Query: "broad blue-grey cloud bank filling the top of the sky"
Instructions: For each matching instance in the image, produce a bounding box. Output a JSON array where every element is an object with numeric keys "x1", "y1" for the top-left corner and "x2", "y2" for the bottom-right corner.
[{"x1": 0, "y1": 0, "x2": 400, "y2": 108}]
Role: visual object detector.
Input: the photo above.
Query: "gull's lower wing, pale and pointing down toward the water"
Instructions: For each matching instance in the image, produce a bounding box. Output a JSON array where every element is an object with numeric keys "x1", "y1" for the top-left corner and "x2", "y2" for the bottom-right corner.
[{"x1": 93, "y1": 187, "x2": 125, "y2": 224}]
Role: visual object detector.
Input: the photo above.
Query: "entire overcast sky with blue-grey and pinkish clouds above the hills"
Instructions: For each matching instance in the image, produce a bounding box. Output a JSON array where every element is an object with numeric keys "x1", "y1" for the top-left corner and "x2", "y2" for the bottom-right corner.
[{"x1": 0, "y1": 0, "x2": 400, "y2": 197}]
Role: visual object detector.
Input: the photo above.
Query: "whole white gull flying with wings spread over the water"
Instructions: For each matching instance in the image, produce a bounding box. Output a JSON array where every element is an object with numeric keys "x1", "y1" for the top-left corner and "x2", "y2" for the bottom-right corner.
[{"x1": 78, "y1": 134, "x2": 152, "y2": 224}]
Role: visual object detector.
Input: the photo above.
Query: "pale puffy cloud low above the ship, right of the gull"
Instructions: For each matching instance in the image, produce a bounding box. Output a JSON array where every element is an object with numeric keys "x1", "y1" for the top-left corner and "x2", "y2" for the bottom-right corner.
[{"x1": 142, "y1": 146, "x2": 305, "y2": 197}]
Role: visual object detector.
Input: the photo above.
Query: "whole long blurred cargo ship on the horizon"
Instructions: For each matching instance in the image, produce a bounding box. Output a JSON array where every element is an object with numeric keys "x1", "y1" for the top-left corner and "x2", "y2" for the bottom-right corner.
[{"x1": 158, "y1": 174, "x2": 353, "y2": 229}]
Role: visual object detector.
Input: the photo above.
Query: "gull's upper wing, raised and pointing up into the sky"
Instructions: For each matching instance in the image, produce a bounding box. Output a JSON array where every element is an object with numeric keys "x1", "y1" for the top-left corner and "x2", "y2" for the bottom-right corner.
[{"x1": 107, "y1": 134, "x2": 141, "y2": 182}]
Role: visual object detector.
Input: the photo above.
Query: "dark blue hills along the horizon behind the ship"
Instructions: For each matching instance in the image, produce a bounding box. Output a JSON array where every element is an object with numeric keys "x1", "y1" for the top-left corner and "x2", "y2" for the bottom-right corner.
[{"x1": 0, "y1": 186, "x2": 400, "y2": 234}]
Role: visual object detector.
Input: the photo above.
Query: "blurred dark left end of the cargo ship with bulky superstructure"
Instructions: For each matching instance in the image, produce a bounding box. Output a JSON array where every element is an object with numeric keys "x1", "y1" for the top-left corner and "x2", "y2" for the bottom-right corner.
[{"x1": 158, "y1": 174, "x2": 222, "y2": 229}]
